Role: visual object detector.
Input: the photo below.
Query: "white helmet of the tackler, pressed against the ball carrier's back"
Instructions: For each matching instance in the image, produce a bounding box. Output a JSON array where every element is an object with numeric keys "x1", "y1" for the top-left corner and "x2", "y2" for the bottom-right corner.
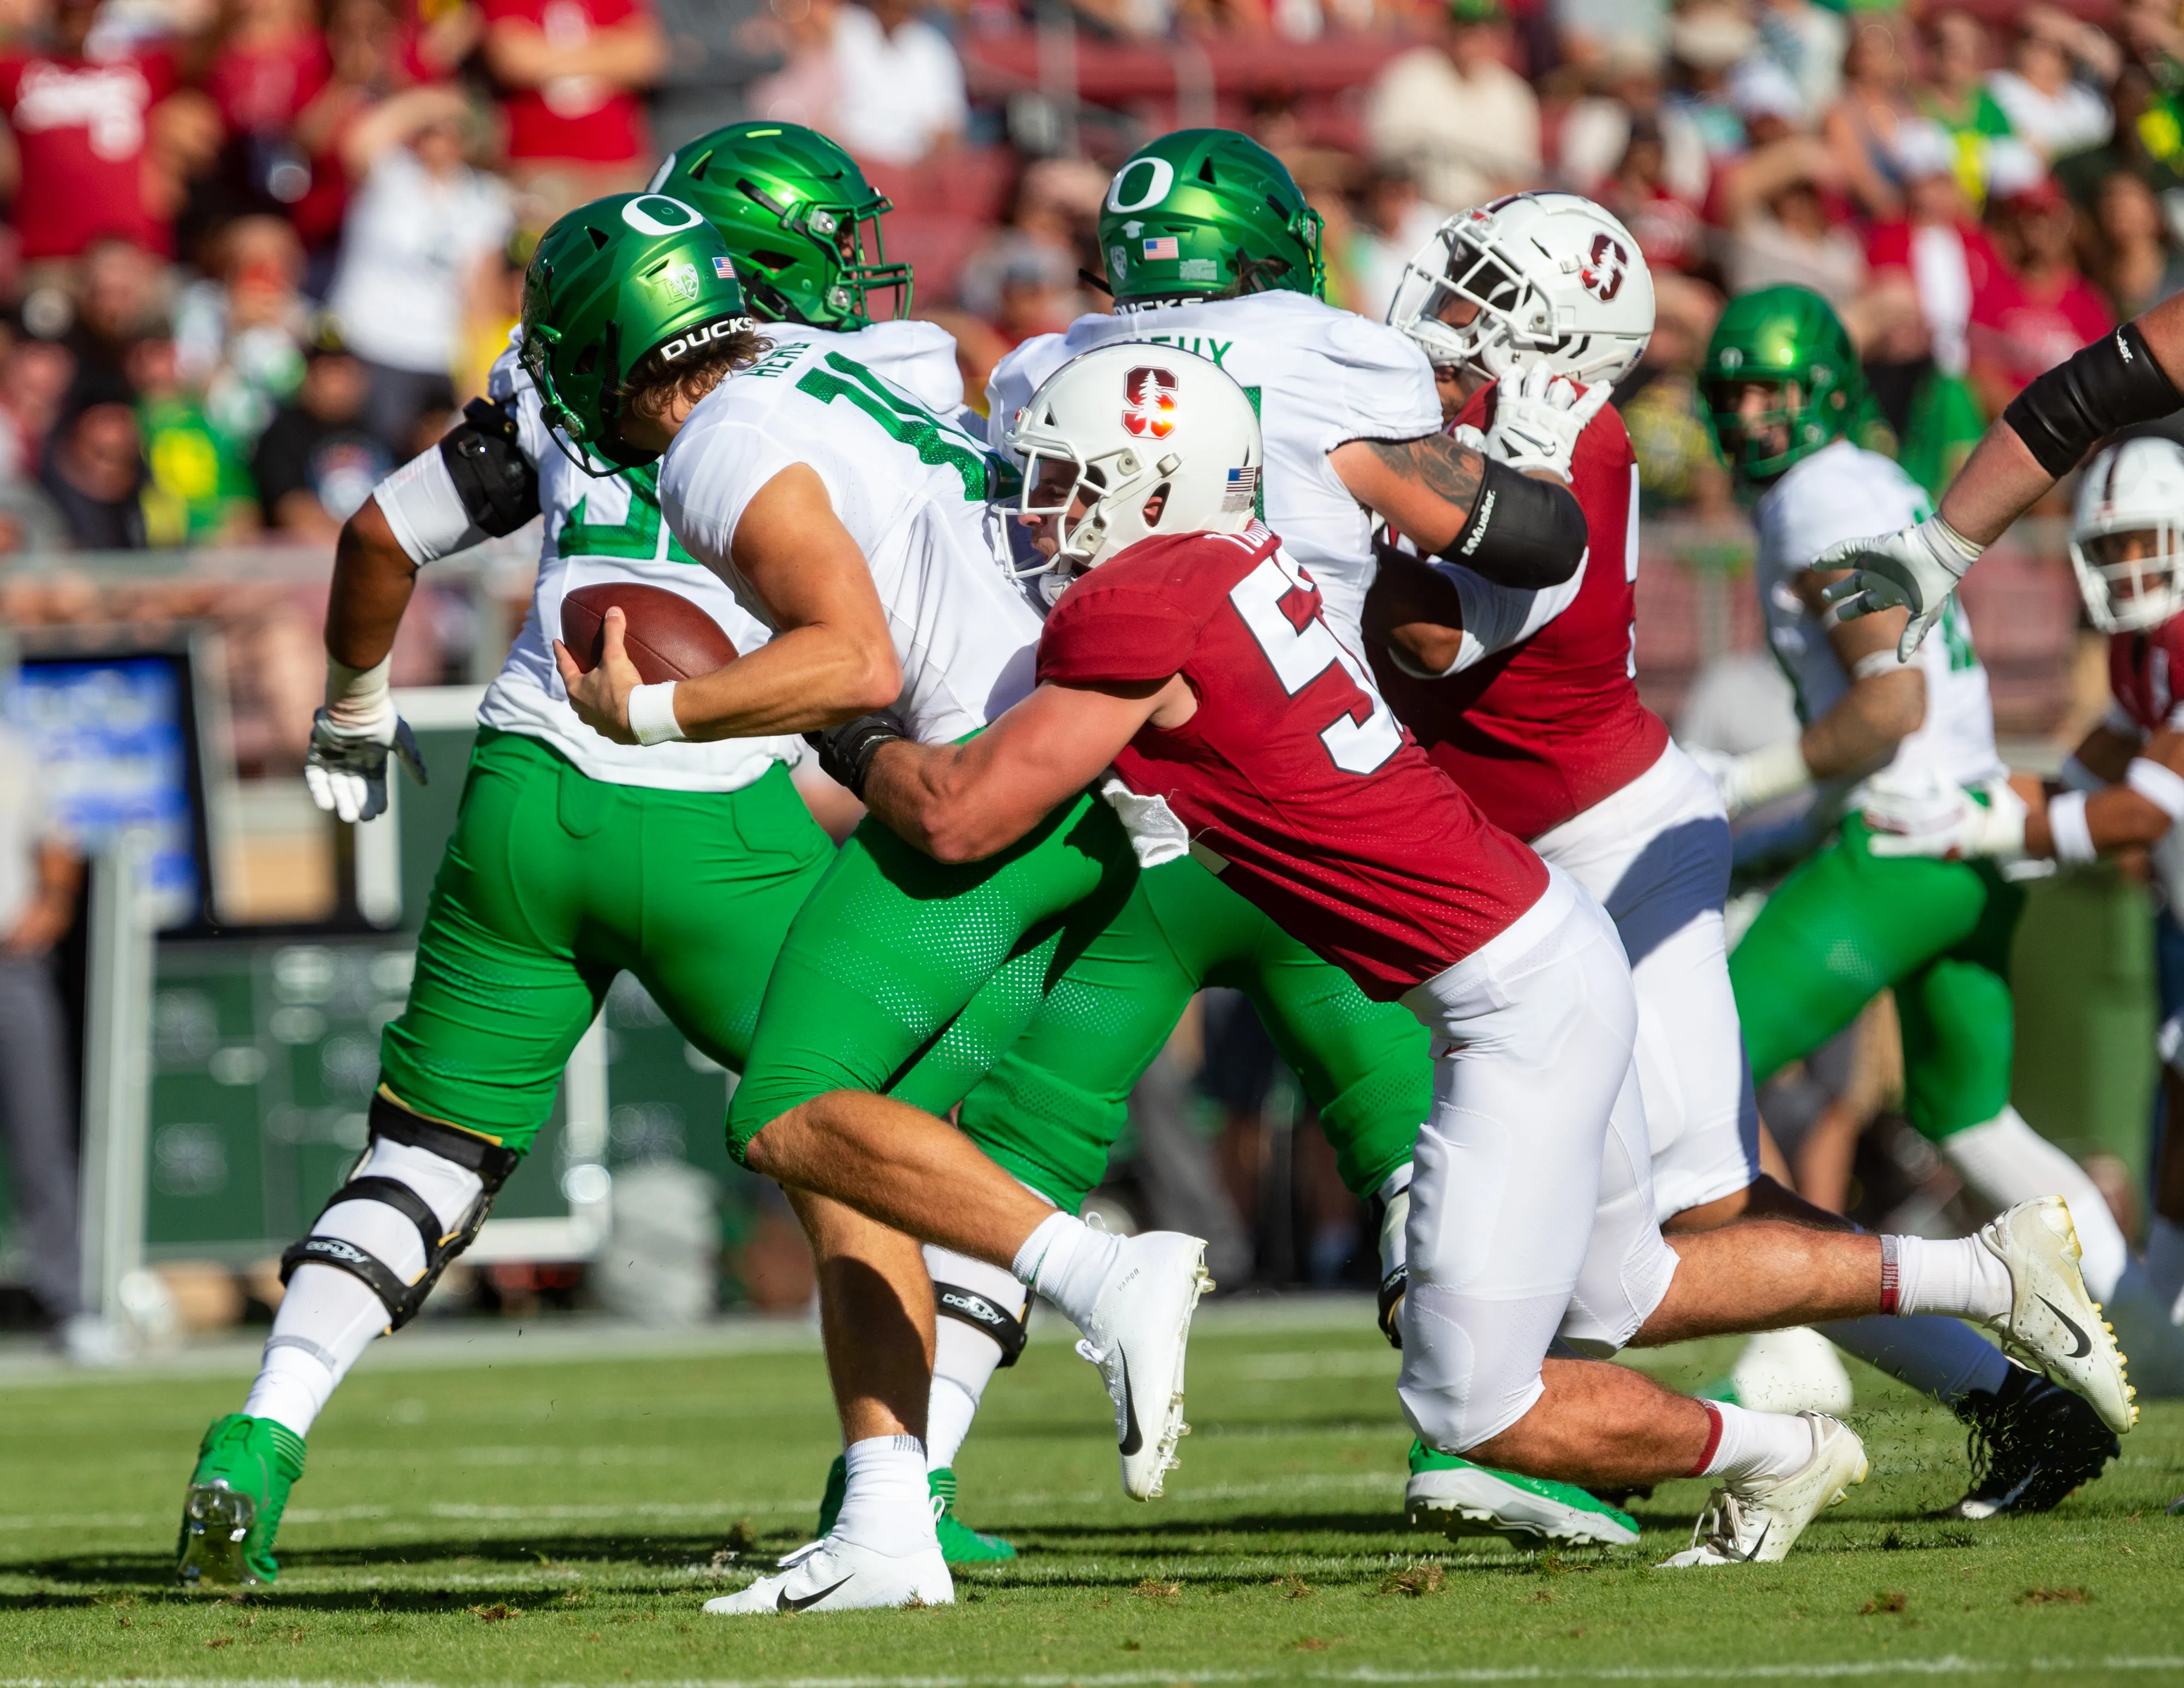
[{"x1": 1002, "y1": 343, "x2": 1265, "y2": 579}]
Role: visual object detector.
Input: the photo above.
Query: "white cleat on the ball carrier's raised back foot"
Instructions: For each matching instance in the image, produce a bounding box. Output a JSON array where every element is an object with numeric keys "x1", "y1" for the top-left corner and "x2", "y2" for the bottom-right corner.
[{"x1": 1077, "y1": 1231, "x2": 1214, "y2": 1500}]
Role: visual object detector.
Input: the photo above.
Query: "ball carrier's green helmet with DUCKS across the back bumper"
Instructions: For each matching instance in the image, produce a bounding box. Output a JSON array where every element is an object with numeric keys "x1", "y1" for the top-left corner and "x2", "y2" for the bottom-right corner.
[{"x1": 522, "y1": 194, "x2": 758, "y2": 474}]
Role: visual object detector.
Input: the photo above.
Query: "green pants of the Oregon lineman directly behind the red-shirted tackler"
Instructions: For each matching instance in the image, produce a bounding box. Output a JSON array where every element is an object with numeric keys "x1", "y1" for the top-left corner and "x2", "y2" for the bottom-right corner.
[{"x1": 935, "y1": 856, "x2": 1433, "y2": 1212}]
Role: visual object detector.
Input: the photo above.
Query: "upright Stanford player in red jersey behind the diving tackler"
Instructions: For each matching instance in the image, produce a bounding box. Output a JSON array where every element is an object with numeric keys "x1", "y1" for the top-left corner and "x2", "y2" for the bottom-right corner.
[{"x1": 1365, "y1": 192, "x2": 2116, "y2": 1546}]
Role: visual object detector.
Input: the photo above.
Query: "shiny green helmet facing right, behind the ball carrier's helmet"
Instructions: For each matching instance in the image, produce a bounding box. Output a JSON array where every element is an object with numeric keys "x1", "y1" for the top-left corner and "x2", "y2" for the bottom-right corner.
[{"x1": 653, "y1": 122, "x2": 911, "y2": 332}]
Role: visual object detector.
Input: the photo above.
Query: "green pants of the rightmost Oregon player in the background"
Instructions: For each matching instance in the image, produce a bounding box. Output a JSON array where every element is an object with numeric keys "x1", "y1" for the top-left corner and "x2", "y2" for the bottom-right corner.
[{"x1": 1730, "y1": 815, "x2": 2025, "y2": 1140}]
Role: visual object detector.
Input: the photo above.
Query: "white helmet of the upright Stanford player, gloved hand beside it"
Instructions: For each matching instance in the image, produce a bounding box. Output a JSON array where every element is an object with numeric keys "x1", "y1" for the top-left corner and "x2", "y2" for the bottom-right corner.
[{"x1": 1387, "y1": 192, "x2": 1653, "y2": 384}]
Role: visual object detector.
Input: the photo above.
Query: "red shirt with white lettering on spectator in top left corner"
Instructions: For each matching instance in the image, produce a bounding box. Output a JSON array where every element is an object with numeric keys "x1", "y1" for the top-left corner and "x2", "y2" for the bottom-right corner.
[{"x1": 0, "y1": 48, "x2": 175, "y2": 260}]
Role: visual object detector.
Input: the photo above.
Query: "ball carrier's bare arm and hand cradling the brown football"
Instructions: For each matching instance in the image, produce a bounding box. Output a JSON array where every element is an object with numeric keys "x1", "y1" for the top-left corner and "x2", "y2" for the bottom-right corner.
[{"x1": 555, "y1": 463, "x2": 902, "y2": 745}]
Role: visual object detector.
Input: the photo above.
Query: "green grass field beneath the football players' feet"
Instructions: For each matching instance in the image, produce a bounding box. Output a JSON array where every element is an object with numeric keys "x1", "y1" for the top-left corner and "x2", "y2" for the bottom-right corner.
[{"x1": 0, "y1": 1304, "x2": 2184, "y2": 1688}]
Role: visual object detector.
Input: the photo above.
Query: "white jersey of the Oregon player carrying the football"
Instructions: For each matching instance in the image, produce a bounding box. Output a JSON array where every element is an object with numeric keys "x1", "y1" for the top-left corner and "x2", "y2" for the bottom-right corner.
[{"x1": 660, "y1": 336, "x2": 1040, "y2": 745}]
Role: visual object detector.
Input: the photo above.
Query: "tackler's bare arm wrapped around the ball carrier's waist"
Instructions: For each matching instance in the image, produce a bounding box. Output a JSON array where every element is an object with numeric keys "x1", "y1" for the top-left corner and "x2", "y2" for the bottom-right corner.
[{"x1": 865, "y1": 675, "x2": 1199, "y2": 862}]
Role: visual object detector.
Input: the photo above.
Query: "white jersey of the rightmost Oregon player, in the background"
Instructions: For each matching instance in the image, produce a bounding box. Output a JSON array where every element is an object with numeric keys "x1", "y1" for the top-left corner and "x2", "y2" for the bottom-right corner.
[{"x1": 1756, "y1": 439, "x2": 2005, "y2": 803}]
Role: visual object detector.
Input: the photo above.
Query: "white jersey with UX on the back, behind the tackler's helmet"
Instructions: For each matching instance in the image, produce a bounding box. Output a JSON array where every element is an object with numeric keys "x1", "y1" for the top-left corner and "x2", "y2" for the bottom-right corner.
[{"x1": 985, "y1": 293, "x2": 1441, "y2": 651}]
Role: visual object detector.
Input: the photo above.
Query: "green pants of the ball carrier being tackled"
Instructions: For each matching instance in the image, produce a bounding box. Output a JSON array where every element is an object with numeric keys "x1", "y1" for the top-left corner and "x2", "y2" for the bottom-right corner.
[{"x1": 727, "y1": 795, "x2": 1138, "y2": 1159}]
